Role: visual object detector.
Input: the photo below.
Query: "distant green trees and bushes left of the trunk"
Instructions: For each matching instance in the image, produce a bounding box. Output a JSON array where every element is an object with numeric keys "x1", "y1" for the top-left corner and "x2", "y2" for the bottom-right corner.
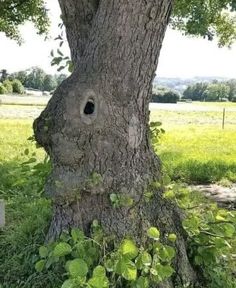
[{"x1": 0, "y1": 67, "x2": 67, "y2": 94}]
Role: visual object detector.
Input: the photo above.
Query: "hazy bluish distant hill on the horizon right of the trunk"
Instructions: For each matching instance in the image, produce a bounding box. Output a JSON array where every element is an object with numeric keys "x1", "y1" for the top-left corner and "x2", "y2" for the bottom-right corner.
[{"x1": 153, "y1": 76, "x2": 232, "y2": 93}]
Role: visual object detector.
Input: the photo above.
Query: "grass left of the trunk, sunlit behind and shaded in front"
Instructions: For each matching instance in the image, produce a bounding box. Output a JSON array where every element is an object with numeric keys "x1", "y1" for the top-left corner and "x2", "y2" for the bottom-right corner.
[{"x1": 0, "y1": 120, "x2": 54, "y2": 288}]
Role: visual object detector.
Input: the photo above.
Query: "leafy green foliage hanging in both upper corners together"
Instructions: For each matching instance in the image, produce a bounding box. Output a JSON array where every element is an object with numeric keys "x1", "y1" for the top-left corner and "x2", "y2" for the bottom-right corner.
[{"x1": 0, "y1": 0, "x2": 236, "y2": 46}]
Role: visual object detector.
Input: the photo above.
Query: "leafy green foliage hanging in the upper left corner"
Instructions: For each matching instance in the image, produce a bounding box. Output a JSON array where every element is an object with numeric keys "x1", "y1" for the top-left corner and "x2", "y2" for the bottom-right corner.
[{"x1": 0, "y1": 0, "x2": 49, "y2": 43}]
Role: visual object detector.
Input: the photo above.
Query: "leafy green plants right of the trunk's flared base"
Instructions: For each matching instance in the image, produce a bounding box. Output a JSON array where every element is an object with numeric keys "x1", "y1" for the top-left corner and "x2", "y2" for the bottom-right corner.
[{"x1": 165, "y1": 183, "x2": 236, "y2": 288}]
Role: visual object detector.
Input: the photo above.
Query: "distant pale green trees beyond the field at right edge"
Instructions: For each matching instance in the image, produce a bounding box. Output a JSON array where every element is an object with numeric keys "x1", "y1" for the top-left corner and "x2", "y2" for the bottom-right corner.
[{"x1": 183, "y1": 79, "x2": 236, "y2": 102}]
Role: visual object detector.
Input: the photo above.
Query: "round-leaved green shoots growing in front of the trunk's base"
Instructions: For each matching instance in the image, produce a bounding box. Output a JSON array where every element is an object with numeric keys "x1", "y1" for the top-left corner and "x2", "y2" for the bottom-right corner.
[{"x1": 35, "y1": 220, "x2": 176, "y2": 288}]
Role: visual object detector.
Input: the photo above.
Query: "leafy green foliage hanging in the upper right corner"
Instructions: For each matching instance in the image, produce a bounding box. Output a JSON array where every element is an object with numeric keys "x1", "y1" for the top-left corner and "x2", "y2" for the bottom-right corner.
[{"x1": 171, "y1": 0, "x2": 236, "y2": 46}]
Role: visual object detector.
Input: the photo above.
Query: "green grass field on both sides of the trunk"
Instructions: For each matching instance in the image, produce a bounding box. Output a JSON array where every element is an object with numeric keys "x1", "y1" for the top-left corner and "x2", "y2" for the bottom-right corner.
[{"x1": 0, "y1": 104, "x2": 236, "y2": 288}]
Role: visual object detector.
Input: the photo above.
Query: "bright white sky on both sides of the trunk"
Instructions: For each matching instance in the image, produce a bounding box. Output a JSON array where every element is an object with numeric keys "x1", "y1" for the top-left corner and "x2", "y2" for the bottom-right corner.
[{"x1": 0, "y1": 0, "x2": 236, "y2": 78}]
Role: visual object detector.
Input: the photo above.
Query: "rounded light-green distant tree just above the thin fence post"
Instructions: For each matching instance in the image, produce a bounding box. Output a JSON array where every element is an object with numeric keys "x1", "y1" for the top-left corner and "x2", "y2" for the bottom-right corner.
[{"x1": 204, "y1": 83, "x2": 230, "y2": 101}]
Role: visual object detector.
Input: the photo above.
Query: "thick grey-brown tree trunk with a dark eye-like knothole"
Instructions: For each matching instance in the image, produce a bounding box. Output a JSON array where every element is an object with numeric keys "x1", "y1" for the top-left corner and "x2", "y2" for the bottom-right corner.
[{"x1": 34, "y1": 0, "x2": 199, "y2": 287}]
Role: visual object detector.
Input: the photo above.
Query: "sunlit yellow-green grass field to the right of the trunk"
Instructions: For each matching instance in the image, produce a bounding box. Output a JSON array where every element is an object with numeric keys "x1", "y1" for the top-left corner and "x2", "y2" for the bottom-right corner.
[{"x1": 151, "y1": 110, "x2": 236, "y2": 184}]
